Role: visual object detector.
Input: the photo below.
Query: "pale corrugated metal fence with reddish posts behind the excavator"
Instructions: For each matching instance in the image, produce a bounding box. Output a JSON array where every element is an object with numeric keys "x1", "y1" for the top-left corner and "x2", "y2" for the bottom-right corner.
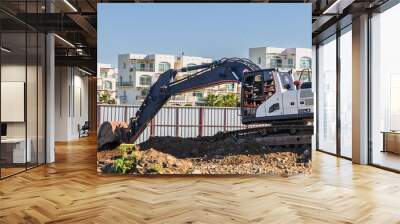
[{"x1": 97, "y1": 105, "x2": 257, "y2": 143}]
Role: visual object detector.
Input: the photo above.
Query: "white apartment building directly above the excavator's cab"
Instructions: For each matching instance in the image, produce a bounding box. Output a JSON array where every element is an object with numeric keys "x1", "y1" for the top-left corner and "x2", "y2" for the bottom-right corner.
[{"x1": 249, "y1": 47, "x2": 312, "y2": 78}]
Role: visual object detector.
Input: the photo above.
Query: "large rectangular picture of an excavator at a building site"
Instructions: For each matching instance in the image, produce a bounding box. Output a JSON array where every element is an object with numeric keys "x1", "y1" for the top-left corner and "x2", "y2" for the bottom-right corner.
[{"x1": 97, "y1": 4, "x2": 314, "y2": 176}]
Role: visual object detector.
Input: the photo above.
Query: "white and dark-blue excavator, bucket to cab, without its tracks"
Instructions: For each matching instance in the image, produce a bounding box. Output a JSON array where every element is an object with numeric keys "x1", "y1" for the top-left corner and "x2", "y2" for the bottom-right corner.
[{"x1": 97, "y1": 58, "x2": 313, "y2": 150}]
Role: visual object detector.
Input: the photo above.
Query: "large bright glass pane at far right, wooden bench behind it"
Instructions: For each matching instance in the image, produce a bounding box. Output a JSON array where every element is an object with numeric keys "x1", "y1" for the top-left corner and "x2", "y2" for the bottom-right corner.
[{"x1": 370, "y1": 4, "x2": 400, "y2": 170}]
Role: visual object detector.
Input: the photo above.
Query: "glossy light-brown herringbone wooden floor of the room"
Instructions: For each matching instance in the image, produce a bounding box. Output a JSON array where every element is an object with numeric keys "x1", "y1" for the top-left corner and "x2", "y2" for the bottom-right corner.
[{"x1": 0, "y1": 138, "x2": 400, "y2": 223}]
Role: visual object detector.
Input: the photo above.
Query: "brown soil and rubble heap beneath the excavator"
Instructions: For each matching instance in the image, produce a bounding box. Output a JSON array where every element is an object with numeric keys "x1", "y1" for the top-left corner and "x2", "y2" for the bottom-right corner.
[{"x1": 98, "y1": 136, "x2": 311, "y2": 176}]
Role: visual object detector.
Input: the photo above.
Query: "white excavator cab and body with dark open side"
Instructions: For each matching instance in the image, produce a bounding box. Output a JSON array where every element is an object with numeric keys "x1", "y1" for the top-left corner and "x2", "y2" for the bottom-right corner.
[{"x1": 241, "y1": 69, "x2": 313, "y2": 124}]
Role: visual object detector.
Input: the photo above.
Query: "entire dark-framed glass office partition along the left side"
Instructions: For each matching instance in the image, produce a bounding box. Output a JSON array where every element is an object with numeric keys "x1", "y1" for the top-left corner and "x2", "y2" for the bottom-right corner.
[{"x1": 0, "y1": 1, "x2": 46, "y2": 178}]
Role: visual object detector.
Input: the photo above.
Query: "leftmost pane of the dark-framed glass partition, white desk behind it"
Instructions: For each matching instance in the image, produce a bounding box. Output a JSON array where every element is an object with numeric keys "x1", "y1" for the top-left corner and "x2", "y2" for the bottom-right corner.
[{"x1": 0, "y1": 32, "x2": 27, "y2": 177}]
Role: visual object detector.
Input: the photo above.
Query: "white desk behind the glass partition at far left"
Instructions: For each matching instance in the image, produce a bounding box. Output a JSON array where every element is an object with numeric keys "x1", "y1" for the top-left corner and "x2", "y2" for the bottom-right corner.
[{"x1": 1, "y1": 138, "x2": 32, "y2": 163}]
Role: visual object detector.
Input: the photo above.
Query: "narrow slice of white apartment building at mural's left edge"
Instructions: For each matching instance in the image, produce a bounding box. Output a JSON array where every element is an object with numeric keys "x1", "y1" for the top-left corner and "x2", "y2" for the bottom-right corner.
[{"x1": 97, "y1": 63, "x2": 118, "y2": 103}]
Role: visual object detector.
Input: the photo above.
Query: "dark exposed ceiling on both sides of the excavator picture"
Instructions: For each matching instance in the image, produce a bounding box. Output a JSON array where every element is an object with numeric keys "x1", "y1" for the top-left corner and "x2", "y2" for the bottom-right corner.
[{"x1": 0, "y1": 0, "x2": 394, "y2": 74}]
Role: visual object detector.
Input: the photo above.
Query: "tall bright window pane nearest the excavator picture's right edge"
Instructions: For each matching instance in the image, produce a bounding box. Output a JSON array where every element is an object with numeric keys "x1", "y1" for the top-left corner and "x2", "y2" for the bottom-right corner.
[{"x1": 317, "y1": 35, "x2": 337, "y2": 153}]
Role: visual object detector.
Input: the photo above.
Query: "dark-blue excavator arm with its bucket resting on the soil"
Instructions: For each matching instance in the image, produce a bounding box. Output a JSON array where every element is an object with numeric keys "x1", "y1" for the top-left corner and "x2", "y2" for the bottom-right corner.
[{"x1": 97, "y1": 58, "x2": 260, "y2": 150}]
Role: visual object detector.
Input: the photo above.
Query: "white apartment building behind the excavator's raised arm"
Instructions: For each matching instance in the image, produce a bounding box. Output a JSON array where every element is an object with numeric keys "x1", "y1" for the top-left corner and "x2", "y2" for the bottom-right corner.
[{"x1": 116, "y1": 53, "x2": 240, "y2": 106}]
